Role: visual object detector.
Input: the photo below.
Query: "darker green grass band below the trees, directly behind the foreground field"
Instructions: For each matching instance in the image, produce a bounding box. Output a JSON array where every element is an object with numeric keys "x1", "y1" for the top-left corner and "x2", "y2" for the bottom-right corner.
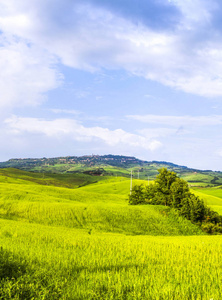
[{"x1": 0, "y1": 202, "x2": 202, "y2": 236}]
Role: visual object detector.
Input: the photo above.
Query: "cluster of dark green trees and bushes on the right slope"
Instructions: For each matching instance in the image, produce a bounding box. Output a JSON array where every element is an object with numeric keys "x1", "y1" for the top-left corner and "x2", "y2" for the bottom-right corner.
[{"x1": 129, "y1": 168, "x2": 222, "y2": 233}]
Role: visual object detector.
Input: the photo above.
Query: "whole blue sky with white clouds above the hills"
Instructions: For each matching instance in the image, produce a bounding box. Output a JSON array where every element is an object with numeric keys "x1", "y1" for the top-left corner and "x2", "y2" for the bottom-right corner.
[{"x1": 0, "y1": 0, "x2": 222, "y2": 171}]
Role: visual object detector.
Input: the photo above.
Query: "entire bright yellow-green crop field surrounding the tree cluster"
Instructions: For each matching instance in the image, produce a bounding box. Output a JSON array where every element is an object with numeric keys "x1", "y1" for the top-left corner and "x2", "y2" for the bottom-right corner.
[{"x1": 0, "y1": 170, "x2": 222, "y2": 300}]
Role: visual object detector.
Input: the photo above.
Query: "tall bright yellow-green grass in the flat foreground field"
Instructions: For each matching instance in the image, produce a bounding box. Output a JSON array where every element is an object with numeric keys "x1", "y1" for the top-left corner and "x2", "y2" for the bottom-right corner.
[{"x1": 0, "y1": 220, "x2": 222, "y2": 300}]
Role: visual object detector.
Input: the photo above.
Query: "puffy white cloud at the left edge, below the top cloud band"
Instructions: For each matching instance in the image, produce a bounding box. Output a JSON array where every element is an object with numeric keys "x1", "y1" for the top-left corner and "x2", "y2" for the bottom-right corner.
[{"x1": 0, "y1": 36, "x2": 62, "y2": 107}]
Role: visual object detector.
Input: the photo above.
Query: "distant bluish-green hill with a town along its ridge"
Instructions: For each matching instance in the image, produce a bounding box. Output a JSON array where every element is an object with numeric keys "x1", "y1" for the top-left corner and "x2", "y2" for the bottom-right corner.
[{"x1": 0, "y1": 154, "x2": 222, "y2": 187}]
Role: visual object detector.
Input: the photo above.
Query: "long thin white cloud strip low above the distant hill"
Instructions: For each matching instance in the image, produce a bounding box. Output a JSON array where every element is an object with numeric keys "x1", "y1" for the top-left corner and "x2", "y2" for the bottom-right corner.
[{"x1": 5, "y1": 116, "x2": 162, "y2": 151}]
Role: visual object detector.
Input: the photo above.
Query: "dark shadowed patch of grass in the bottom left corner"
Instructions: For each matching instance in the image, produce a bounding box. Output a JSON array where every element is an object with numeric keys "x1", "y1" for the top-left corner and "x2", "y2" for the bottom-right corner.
[{"x1": 0, "y1": 248, "x2": 62, "y2": 300}]
